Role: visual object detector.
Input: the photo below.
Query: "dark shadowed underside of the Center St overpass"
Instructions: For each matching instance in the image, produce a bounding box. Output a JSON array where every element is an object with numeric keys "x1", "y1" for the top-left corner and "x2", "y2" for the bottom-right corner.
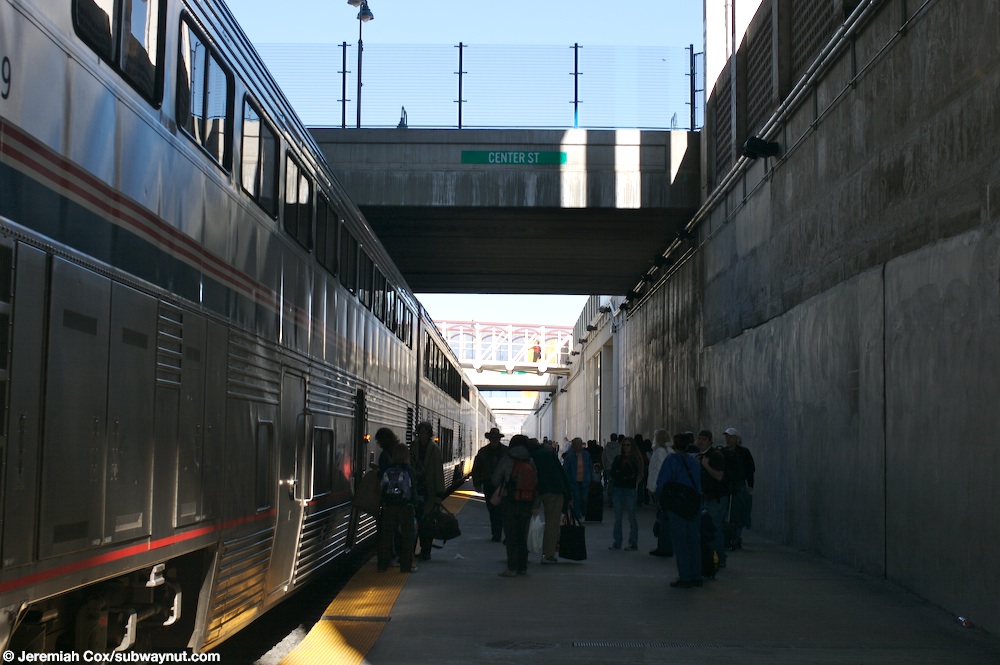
[{"x1": 361, "y1": 205, "x2": 694, "y2": 295}]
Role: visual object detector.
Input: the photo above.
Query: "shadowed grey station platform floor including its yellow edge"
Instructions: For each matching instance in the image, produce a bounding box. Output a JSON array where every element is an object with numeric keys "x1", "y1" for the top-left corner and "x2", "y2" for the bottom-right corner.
[{"x1": 281, "y1": 484, "x2": 1000, "y2": 665}]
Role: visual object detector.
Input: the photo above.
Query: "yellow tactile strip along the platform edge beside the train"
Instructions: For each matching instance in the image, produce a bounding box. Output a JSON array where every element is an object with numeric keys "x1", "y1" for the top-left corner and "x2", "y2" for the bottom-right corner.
[{"x1": 280, "y1": 491, "x2": 472, "y2": 665}]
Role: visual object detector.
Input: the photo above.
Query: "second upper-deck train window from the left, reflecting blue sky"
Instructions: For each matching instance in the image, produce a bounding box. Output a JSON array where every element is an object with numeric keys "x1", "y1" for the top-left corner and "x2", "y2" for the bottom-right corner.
[{"x1": 177, "y1": 19, "x2": 233, "y2": 171}]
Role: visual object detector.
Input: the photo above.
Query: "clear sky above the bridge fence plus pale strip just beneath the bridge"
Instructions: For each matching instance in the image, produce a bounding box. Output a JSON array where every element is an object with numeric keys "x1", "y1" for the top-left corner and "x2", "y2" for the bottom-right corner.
[{"x1": 226, "y1": 0, "x2": 704, "y2": 325}]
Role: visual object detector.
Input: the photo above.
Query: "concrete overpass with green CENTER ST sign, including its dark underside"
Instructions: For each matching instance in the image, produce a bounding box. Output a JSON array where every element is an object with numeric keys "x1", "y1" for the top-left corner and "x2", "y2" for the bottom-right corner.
[{"x1": 312, "y1": 128, "x2": 701, "y2": 295}]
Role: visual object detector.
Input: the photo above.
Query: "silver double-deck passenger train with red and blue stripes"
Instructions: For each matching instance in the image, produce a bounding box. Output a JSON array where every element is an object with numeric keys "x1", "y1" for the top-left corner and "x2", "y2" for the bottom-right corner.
[{"x1": 0, "y1": 0, "x2": 492, "y2": 653}]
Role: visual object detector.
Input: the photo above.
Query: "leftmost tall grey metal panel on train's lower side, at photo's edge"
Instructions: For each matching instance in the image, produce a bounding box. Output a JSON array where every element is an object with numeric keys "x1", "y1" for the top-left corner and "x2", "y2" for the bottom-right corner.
[{"x1": 0, "y1": 244, "x2": 48, "y2": 568}]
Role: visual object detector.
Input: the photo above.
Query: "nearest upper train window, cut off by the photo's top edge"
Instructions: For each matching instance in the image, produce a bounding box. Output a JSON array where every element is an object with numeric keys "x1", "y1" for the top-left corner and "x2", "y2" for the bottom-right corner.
[{"x1": 73, "y1": 0, "x2": 166, "y2": 106}]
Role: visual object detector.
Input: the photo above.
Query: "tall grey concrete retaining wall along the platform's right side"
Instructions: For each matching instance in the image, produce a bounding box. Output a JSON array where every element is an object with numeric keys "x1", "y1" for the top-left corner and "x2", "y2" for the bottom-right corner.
[{"x1": 619, "y1": 0, "x2": 1000, "y2": 632}]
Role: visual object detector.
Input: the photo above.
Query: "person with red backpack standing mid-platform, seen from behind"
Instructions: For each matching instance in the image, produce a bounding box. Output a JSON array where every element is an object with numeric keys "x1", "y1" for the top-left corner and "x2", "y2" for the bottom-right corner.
[{"x1": 490, "y1": 434, "x2": 538, "y2": 577}]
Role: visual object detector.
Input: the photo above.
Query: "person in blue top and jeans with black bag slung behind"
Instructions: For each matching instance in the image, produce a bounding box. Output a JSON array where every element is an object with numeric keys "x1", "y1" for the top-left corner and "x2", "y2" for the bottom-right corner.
[{"x1": 656, "y1": 434, "x2": 702, "y2": 589}]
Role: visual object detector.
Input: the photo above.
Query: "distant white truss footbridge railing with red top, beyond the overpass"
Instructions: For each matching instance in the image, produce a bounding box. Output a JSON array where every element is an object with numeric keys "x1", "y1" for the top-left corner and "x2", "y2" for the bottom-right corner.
[{"x1": 435, "y1": 321, "x2": 573, "y2": 374}]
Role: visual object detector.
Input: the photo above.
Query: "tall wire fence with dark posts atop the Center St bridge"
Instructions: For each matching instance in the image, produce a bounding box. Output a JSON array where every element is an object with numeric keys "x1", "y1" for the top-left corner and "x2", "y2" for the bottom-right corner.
[{"x1": 256, "y1": 43, "x2": 705, "y2": 130}]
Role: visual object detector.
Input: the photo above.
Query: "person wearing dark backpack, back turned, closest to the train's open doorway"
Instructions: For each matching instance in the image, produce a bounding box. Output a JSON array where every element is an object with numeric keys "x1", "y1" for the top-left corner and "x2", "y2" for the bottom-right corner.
[{"x1": 378, "y1": 441, "x2": 417, "y2": 573}]
